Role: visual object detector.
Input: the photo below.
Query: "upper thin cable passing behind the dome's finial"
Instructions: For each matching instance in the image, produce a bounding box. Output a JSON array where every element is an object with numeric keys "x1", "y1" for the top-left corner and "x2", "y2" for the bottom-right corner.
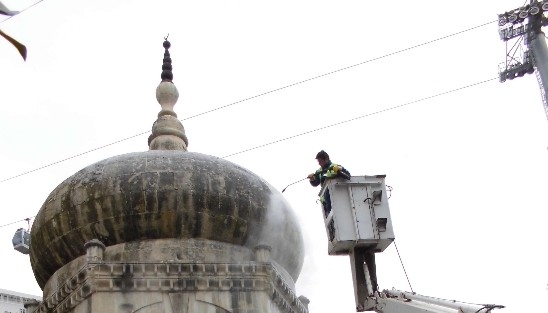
[{"x1": 0, "y1": 19, "x2": 497, "y2": 183}]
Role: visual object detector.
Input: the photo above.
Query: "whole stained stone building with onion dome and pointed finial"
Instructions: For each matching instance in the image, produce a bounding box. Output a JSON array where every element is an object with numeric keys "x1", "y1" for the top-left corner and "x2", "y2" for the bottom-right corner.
[{"x1": 27, "y1": 40, "x2": 308, "y2": 313}]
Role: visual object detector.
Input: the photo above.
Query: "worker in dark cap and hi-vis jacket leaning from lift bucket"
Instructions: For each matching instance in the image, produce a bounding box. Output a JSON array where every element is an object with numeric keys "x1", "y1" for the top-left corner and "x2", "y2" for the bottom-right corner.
[{"x1": 308, "y1": 150, "x2": 350, "y2": 217}]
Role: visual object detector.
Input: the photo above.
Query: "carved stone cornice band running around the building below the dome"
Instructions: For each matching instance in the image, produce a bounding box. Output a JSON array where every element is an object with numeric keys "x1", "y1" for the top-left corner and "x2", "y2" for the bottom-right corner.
[{"x1": 35, "y1": 260, "x2": 308, "y2": 313}]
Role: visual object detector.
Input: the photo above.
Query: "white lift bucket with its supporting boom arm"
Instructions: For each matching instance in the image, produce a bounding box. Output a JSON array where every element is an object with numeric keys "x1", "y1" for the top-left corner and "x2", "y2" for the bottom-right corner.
[{"x1": 319, "y1": 177, "x2": 506, "y2": 313}]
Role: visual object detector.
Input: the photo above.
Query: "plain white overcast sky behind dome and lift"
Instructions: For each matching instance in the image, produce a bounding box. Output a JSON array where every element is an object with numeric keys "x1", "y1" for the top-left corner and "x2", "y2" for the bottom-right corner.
[{"x1": 0, "y1": 0, "x2": 548, "y2": 313}]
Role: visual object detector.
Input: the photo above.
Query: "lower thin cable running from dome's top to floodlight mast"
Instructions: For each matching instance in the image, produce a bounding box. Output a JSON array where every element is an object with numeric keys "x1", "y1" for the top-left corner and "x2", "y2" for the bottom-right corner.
[{"x1": 222, "y1": 77, "x2": 498, "y2": 159}]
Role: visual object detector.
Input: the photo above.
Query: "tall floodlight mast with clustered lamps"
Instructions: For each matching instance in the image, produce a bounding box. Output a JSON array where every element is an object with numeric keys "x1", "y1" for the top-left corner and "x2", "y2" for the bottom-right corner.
[{"x1": 498, "y1": 0, "x2": 548, "y2": 118}]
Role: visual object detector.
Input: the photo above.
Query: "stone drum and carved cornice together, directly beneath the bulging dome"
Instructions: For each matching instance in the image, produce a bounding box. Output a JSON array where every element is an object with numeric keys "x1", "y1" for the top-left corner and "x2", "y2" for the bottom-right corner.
[{"x1": 43, "y1": 238, "x2": 295, "y2": 302}]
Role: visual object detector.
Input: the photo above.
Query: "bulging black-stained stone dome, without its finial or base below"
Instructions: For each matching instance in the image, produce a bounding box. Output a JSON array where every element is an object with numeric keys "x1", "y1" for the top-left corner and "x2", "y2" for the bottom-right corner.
[{"x1": 30, "y1": 150, "x2": 303, "y2": 287}]
